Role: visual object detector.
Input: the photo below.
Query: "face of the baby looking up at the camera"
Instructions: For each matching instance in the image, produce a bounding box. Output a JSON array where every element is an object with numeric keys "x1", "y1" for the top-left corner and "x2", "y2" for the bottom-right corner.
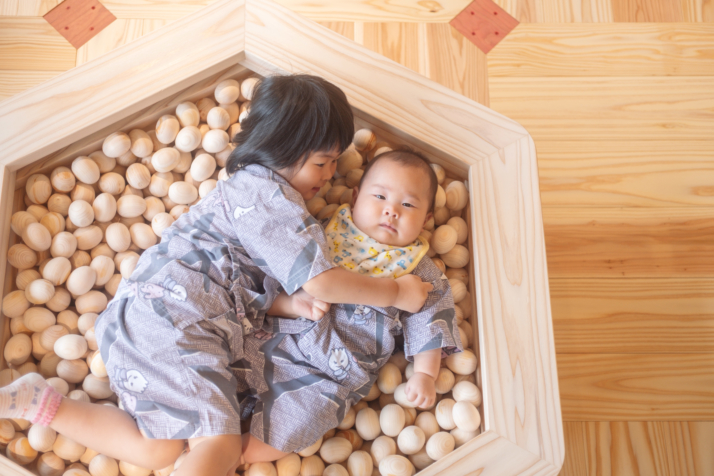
[{"x1": 352, "y1": 160, "x2": 431, "y2": 246}]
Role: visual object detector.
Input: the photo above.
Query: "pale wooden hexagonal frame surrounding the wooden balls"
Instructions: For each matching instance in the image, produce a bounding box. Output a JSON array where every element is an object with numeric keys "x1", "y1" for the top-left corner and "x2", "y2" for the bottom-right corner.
[{"x1": 0, "y1": 0, "x2": 564, "y2": 476}]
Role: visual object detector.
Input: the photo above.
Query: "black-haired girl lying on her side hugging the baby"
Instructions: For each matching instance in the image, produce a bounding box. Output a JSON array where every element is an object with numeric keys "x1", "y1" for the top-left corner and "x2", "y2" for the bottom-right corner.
[{"x1": 0, "y1": 75, "x2": 431, "y2": 476}]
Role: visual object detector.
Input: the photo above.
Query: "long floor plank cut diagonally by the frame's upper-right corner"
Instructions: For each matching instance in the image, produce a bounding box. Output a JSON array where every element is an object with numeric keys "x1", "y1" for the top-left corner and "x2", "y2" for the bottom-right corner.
[{"x1": 489, "y1": 76, "x2": 714, "y2": 143}]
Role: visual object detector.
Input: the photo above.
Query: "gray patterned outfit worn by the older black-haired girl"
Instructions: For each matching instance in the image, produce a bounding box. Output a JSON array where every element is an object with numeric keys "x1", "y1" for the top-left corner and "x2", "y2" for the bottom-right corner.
[{"x1": 95, "y1": 165, "x2": 333, "y2": 439}]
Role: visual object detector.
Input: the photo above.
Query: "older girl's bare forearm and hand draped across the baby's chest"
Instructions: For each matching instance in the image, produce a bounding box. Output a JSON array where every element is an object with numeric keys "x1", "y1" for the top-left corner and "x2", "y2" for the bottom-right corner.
[{"x1": 303, "y1": 268, "x2": 433, "y2": 312}]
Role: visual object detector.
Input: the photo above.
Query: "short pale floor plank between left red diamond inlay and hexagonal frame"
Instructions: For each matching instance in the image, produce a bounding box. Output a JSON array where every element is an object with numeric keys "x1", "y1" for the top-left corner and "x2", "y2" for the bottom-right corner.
[{"x1": 77, "y1": 19, "x2": 168, "y2": 66}]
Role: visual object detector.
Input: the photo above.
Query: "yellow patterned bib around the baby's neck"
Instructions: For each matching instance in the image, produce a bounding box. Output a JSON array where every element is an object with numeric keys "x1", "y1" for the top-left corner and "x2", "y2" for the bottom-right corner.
[{"x1": 325, "y1": 204, "x2": 429, "y2": 279}]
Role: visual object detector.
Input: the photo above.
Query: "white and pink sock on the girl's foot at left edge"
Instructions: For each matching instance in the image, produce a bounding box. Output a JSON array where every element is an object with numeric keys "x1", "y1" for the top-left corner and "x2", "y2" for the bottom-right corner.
[{"x1": 0, "y1": 373, "x2": 62, "y2": 426}]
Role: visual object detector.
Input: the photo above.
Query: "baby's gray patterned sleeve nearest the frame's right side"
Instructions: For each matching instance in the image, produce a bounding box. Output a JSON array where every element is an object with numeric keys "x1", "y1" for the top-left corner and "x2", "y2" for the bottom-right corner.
[{"x1": 400, "y1": 256, "x2": 463, "y2": 361}]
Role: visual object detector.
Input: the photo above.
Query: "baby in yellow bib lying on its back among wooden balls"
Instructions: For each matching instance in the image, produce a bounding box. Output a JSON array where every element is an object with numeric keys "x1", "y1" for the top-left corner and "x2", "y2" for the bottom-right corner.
[{"x1": 233, "y1": 150, "x2": 463, "y2": 461}]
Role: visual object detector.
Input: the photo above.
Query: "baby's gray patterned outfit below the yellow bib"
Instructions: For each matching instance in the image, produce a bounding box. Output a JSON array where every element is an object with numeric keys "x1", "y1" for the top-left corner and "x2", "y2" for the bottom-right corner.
[{"x1": 233, "y1": 256, "x2": 463, "y2": 452}]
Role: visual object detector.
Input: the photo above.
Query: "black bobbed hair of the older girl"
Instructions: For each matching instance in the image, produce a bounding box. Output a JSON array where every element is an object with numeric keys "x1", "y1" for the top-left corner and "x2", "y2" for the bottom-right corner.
[{"x1": 226, "y1": 74, "x2": 354, "y2": 174}]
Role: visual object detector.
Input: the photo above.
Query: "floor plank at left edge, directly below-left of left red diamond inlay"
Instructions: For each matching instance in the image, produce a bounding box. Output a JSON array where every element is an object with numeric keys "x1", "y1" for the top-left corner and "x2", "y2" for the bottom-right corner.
[{"x1": 0, "y1": 17, "x2": 76, "y2": 71}]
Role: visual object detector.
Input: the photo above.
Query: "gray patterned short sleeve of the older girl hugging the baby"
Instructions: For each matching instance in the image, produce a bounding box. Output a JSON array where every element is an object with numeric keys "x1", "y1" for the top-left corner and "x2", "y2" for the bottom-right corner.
[{"x1": 223, "y1": 167, "x2": 333, "y2": 294}]
